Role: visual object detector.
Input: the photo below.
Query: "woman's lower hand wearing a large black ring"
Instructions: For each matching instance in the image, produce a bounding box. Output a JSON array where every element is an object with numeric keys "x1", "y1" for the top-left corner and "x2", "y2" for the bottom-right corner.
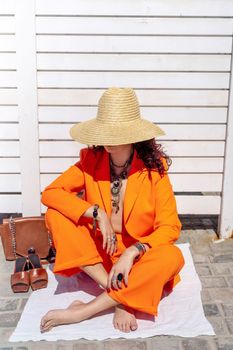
[{"x1": 107, "y1": 246, "x2": 138, "y2": 289}]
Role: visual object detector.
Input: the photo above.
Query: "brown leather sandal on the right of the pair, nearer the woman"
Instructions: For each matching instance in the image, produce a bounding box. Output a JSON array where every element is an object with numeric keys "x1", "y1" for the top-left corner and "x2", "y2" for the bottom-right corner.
[{"x1": 28, "y1": 254, "x2": 48, "y2": 290}]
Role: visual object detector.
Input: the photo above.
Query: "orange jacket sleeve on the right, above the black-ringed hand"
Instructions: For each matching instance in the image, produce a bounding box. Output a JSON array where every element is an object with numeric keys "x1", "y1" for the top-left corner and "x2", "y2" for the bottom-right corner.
[{"x1": 140, "y1": 170, "x2": 182, "y2": 247}]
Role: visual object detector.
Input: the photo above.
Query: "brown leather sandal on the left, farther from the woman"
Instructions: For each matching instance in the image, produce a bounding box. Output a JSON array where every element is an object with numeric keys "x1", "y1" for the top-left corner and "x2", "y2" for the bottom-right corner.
[{"x1": 11, "y1": 257, "x2": 30, "y2": 293}]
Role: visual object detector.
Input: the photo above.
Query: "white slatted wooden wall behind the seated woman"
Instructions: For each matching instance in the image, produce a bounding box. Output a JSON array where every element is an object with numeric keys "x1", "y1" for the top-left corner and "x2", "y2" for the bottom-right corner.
[{"x1": 0, "y1": 0, "x2": 233, "y2": 236}]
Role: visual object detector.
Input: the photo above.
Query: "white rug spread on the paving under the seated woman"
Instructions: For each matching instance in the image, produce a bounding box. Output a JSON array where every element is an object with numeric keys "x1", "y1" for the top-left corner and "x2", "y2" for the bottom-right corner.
[{"x1": 9, "y1": 243, "x2": 215, "y2": 342}]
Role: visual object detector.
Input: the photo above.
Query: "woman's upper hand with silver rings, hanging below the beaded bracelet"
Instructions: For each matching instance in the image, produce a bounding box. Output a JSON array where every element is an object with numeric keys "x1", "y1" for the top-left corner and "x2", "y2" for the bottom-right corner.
[{"x1": 97, "y1": 209, "x2": 117, "y2": 255}]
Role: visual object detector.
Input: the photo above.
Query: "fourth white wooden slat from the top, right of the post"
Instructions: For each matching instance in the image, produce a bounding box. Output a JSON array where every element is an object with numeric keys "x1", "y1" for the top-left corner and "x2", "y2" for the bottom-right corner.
[{"x1": 36, "y1": 53, "x2": 231, "y2": 72}]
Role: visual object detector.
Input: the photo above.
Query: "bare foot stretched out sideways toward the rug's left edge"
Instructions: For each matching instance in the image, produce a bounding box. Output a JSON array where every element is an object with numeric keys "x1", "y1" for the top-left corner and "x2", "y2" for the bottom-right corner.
[{"x1": 40, "y1": 300, "x2": 87, "y2": 332}]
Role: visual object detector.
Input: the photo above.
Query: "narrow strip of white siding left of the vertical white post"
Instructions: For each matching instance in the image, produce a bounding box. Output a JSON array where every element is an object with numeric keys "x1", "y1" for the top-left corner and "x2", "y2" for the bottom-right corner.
[{"x1": 0, "y1": 1, "x2": 19, "y2": 213}]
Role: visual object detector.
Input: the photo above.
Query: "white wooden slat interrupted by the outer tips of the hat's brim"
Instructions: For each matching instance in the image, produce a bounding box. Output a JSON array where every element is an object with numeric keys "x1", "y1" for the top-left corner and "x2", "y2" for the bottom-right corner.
[{"x1": 38, "y1": 124, "x2": 226, "y2": 140}]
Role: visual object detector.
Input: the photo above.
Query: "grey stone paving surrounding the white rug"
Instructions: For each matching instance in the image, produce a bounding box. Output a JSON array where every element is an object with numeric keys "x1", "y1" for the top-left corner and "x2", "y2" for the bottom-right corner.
[{"x1": 0, "y1": 223, "x2": 233, "y2": 350}]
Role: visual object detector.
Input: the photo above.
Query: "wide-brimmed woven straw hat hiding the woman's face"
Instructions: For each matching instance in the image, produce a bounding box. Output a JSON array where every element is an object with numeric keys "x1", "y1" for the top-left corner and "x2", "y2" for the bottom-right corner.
[{"x1": 70, "y1": 87, "x2": 165, "y2": 146}]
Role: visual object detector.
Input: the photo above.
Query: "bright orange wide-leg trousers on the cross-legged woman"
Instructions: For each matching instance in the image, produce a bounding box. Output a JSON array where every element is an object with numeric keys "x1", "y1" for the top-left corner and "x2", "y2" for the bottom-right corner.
[{"x1": 45, "y1": 208, "x2": 184, "y2": 315}]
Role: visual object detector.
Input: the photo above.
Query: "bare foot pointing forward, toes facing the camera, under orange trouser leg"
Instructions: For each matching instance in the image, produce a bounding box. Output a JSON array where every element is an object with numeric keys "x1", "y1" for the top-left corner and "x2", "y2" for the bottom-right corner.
[{"x1": 113, "y1": 305, "x2": 138, "y2": 333}]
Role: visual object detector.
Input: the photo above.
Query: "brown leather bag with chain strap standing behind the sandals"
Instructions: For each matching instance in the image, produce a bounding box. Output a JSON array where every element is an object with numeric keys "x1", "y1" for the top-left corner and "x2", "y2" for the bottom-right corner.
[{"x1": 0, "y1": 216, "x2": 55, "y2": 260}]
